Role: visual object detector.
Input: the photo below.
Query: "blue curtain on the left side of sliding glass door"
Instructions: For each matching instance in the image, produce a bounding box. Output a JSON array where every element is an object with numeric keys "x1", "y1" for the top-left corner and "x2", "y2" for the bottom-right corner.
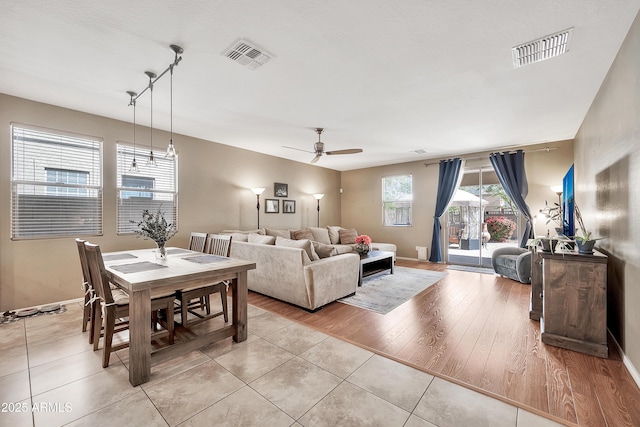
[{"x1": 429, "y1": 158, "x2": 462, "y2": 262}]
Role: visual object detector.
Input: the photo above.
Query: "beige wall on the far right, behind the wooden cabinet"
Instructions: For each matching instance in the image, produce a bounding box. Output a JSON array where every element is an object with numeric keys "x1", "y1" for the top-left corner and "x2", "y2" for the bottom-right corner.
[{"x1": 575, "y1": 10, "x2": 640, "y2": 374}]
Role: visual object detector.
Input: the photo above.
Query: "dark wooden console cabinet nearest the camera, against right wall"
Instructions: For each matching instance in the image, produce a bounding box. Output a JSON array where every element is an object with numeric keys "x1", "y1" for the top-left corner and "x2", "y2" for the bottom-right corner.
[{"x1": 532, "y1": 251, "x2": 609, "y2": 358}]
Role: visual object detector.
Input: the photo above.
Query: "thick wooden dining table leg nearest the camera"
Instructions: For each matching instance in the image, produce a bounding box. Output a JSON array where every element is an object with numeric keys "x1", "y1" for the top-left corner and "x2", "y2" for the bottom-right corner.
[{"x1": 129, "y1": 289, "x2": 151, "y2": 387}]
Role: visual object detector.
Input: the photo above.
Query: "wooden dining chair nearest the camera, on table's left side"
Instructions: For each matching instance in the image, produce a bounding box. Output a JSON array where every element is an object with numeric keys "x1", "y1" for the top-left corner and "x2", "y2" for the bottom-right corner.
[{"x1": 84, "y1": 242, "x2": 175, "y2": 368}]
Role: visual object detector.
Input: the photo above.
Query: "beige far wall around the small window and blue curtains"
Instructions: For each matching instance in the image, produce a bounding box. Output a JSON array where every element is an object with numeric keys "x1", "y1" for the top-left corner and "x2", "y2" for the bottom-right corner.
[{"x1": 342, "y1": 141, "x2": 573, "y2": 258}]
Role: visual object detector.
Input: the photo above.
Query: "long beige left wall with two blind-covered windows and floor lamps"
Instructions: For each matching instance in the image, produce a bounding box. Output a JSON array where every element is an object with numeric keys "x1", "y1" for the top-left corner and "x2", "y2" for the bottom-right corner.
[{"x1": 0, "y1": 94, "x2": 341, "y2": 311}]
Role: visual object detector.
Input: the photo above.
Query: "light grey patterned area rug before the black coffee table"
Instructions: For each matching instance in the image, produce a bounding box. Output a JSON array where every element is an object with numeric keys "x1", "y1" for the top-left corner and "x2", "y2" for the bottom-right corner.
[{"x1": 338, "y1": 267, "x2": 447, "y2": 314}]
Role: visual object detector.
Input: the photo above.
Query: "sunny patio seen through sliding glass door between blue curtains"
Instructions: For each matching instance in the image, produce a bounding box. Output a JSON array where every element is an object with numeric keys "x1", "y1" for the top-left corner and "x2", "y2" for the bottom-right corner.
[{"x1": 446, "y1": 167, "x2": 519, "y2": 267}]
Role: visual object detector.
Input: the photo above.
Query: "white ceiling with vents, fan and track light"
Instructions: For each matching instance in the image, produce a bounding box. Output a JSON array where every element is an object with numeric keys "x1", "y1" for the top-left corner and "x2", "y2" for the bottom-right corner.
[{"x1": 0, "y1": 0, "x2": 640, "y2": 170}]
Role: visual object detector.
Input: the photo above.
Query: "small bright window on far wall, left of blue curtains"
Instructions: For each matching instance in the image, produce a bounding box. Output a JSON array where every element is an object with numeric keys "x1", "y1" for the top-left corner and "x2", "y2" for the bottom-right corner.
[{"x1": 382, "y1": 175, "x2": 413, "y2": 226}]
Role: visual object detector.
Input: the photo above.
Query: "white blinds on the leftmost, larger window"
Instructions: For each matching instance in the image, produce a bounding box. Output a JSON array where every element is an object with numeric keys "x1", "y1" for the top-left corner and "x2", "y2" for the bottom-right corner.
[{"x1": 11, "y1": 123, "x2": 102, "y2": 240}]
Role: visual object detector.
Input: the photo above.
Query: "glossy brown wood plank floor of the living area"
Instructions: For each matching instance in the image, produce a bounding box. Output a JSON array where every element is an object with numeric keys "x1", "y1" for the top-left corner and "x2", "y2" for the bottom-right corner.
[{"x1": 249, "y1": 260, "x2": 640, "y2": 427}]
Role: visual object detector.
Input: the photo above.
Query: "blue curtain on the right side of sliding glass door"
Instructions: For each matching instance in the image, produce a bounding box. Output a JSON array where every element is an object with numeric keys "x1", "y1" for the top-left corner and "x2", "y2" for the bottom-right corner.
[{"x1": 489, "y1": 150, "x2": 534, "y2": 248}]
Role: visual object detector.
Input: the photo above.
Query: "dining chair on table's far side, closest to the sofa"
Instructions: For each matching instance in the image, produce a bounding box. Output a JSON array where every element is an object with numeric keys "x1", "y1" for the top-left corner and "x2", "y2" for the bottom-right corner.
[{"x1": 176, "y1": 234, "x2": 231, "y2": 326}]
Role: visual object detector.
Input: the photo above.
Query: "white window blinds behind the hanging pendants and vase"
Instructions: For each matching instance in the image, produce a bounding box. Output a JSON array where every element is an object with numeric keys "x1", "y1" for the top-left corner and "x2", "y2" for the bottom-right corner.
[{"x1": 117, "y1": 142, "x2": 178, "y2": 234}]
